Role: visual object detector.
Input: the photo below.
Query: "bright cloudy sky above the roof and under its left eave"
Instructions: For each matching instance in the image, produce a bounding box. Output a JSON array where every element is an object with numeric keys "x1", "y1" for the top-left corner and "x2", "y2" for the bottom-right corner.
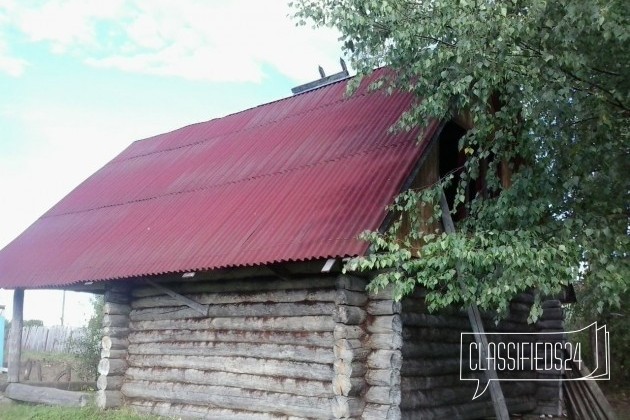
[{"x1": 0, "y1": 0, "x2": 341, "y2": 326}]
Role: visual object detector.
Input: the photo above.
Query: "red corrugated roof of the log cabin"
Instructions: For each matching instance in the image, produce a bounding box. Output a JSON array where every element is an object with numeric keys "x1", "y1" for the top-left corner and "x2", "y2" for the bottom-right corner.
[{"x1": 0, "y1": 72, "x2": 437, "y2": 288}]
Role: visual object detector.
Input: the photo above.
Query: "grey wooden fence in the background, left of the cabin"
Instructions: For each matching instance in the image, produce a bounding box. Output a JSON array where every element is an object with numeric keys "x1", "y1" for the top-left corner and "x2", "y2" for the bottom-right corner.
[{"x1": 22, "y1": 325, "x2": 85, "y2": 353}]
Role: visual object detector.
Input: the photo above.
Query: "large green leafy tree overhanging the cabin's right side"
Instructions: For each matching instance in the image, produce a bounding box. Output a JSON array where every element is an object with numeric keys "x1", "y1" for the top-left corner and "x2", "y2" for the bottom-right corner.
[{"x1": 293, "y1": 0, "x2": 630, "y2": 320}]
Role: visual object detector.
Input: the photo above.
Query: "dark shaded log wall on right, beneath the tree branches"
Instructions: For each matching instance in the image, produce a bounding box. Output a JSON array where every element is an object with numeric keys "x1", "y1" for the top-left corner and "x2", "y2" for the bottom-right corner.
[{"x1": 400, "y1": 293, "x2": 562, "y2": 419}]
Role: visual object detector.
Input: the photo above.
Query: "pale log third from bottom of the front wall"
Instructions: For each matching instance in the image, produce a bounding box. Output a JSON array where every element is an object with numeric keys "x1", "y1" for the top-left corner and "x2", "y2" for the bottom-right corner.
[{"x1": 125, "y1": 367, "x2": 333, "y2": 397}]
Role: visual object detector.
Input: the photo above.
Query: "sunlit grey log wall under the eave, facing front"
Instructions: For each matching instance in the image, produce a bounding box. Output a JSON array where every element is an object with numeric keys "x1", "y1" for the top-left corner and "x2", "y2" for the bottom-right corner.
[{"x1": 121, "y1": 274, "x2": 344, "y2": 419}]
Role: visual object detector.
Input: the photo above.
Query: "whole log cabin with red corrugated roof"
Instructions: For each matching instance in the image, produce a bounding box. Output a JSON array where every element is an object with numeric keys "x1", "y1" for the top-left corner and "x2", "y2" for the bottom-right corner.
[{"x1": 0, "y1": 67, "x2": 563, "y2": 419}]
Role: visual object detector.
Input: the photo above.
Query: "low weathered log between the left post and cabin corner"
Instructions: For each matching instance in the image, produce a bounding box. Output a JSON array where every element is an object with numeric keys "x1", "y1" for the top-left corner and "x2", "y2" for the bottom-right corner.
[{"x1": 4, "y1": 383, "x2": 90, "y2": 407}]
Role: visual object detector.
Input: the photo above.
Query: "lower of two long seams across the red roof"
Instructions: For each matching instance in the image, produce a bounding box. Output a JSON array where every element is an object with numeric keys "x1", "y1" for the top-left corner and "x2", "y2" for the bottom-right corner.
[{"x1": 40, "y1": 139, "x2": 407, "y2": 219}]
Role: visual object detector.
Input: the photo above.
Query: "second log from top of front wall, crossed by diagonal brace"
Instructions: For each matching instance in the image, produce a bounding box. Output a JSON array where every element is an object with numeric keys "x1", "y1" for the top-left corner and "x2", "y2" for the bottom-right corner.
[{"x1": 131, "y1": 289, "x2": 338, "y2": 309}]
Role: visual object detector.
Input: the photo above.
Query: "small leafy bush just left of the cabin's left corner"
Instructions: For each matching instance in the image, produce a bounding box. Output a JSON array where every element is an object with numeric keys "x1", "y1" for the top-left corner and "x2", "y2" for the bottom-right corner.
[{"x1": 70, "y1": 295, "x2": 105, "y2": 381}]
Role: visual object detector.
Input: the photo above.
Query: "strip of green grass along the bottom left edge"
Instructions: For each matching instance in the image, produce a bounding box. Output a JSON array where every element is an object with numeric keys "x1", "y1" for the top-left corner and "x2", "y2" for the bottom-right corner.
[{"x1": 0, "y1": 404, "x2": 164, "y2": 420}]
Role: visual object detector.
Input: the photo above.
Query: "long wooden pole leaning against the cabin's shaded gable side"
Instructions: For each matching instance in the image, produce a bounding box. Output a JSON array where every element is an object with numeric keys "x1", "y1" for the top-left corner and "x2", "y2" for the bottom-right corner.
[{"x1": 440, "y1": 191, "x2": 510, "y2": 420}]
